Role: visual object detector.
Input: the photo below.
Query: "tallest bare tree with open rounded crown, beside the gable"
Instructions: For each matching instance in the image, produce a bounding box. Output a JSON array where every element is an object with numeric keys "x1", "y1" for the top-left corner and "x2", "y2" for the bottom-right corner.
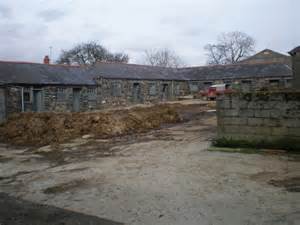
[{"x1": 204, "y1": 31, "x2": 255, "y2": 65}]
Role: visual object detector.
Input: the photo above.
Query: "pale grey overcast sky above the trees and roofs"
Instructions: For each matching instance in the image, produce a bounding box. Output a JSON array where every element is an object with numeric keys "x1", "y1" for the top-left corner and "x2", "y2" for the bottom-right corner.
[{"x1": 0, "y1": 0, "x2": 300, "y2": 65}]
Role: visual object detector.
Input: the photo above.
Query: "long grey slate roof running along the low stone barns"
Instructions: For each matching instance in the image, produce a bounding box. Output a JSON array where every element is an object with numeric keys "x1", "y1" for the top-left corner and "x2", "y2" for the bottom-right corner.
[{"x1": 0, "y1": 59, "x2": 292, "y2": 85}]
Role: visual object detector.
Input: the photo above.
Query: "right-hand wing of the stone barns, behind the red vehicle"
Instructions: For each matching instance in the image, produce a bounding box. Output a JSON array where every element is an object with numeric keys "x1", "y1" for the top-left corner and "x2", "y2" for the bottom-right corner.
[{"x1": 177, "y1": 63, "x2": 292, "y2": 92}]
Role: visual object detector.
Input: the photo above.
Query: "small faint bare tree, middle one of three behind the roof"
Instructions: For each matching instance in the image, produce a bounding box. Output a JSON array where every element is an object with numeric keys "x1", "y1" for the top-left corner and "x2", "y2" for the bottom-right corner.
[{"x1": 144, "y1": 48, "x2": 184, "y2": 68}]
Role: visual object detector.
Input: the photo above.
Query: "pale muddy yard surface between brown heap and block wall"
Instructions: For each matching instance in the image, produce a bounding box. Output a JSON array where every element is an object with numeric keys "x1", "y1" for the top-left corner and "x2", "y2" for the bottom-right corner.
[{"x1": 0, "y1": 100, "x2": 300, "y2": 225}]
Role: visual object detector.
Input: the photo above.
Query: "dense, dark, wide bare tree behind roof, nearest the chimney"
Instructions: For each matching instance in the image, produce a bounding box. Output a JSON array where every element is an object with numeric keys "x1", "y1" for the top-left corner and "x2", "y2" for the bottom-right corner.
[{"x1": 57, "y1": 41, "x2": 129, "y2": 65}]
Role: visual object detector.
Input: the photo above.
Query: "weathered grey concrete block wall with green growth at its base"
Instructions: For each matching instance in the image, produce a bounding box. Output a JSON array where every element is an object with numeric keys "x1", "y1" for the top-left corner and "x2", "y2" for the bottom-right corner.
[{"x1": 217, "y1": 91, "x2": 300, "y2": 148}]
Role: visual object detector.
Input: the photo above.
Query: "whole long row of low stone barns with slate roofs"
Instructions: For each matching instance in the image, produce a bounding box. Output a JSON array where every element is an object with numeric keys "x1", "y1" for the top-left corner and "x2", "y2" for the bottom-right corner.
[{"x1": 0, "y1": 48, "x2": 292, "y2": 121}]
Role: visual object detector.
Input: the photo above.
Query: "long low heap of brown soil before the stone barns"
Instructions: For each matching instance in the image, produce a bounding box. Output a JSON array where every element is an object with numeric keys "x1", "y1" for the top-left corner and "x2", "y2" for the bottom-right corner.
[{"x1": 0, "y1": 105, "x2": 180, "y2": 145}]
